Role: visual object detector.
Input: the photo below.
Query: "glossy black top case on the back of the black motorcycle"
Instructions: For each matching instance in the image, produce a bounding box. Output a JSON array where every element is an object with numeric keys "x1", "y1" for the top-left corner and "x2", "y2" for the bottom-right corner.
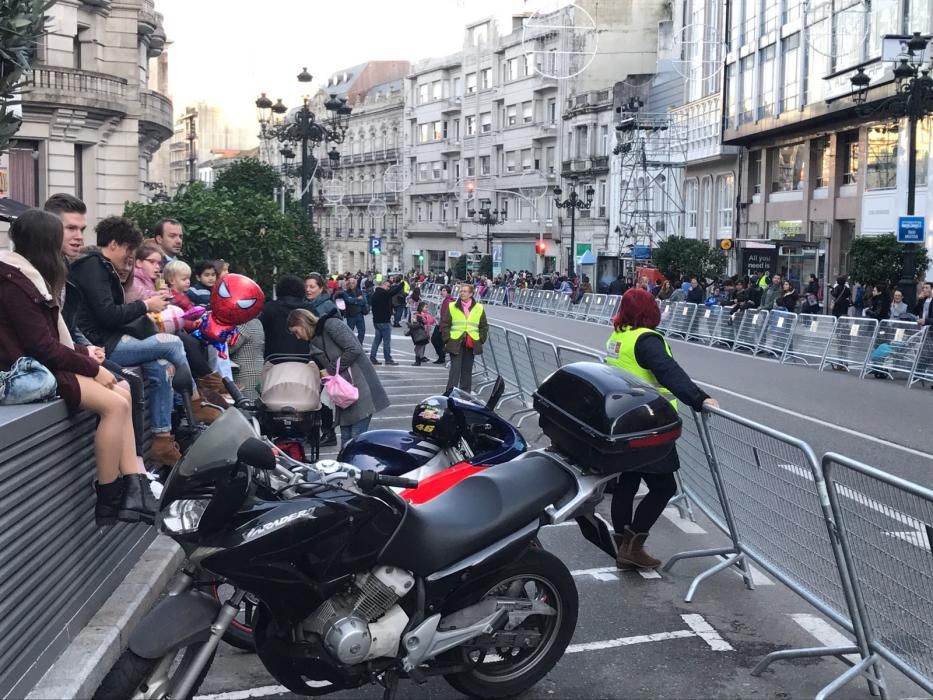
[{"x1": 534, "y1": 362, "x2": 681, "y2": 474}]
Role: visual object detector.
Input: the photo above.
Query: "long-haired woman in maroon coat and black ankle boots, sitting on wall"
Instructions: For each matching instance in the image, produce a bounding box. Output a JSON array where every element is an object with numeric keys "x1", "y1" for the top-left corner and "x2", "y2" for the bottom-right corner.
[{"x1": 0, "y1": 209, "x2": 156, "y2": 527}]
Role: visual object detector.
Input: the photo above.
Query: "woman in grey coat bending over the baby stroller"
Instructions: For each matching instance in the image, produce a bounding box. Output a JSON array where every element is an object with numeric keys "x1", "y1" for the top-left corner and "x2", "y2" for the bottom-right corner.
[{"x1": 288, "y1": 309, "x2": 390, "y2": 445}]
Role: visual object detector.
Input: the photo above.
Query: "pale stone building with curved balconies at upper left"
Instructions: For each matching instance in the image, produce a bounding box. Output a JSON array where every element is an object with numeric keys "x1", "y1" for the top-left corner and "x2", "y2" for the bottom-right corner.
[{"x1": 6, "y1": 0, "x2": 173, "y2": 243}]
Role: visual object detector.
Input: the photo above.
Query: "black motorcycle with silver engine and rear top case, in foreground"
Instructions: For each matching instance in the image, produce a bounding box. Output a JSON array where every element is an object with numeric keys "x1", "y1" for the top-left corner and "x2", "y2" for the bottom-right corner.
[{"x1": 95, "y1": 363, "x2": 680, "y2": 700}]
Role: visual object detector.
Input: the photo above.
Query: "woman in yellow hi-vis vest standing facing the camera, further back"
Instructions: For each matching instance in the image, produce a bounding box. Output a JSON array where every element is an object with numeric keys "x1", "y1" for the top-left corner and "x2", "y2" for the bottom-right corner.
[{"x1": 440, "y1": 284, "x2": 489, "y2": 391}]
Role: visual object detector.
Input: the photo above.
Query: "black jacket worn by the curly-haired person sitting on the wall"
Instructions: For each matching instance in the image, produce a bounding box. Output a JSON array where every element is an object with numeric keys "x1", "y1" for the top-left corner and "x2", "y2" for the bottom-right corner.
[{"x1": 64, "y1": 252, "x2": 146, "y2": 355}]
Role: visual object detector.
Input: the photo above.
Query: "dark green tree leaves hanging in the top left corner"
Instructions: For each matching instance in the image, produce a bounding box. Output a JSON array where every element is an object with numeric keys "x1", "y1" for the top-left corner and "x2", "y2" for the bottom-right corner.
[{"x1": 0, "y1": 0, "x2": 53, "y2": 153}]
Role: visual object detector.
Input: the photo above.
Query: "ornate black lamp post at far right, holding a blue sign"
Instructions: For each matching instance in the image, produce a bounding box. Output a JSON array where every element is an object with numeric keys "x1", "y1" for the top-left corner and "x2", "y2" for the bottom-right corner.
[{"x1": 850, "y1": 32, "x2": 933, "y2": 304}]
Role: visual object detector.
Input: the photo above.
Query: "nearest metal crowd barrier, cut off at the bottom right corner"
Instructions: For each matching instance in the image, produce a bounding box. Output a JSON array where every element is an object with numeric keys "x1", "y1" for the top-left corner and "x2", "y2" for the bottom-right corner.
[{"x1": 822, "y1": 453, "x2": 933, "y2": 693}]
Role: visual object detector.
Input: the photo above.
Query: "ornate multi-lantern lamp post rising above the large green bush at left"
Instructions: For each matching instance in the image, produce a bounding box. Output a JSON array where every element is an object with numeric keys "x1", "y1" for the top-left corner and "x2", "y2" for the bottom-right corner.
[{"x1": 256, "y1": 68, "x2": 352, "y2": 223}]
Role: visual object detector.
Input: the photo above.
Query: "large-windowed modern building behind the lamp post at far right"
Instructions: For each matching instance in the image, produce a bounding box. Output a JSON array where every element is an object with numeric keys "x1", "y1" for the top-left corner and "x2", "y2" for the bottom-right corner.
[{"x1": 723, "y1": 0, "x2": 933, "y2": 284}]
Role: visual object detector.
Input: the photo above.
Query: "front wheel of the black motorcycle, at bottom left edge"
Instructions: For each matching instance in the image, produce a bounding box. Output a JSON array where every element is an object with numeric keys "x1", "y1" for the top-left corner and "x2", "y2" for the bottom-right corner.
[{"x1": 93, "y1": 643, "x2": 214, "y2": 700}]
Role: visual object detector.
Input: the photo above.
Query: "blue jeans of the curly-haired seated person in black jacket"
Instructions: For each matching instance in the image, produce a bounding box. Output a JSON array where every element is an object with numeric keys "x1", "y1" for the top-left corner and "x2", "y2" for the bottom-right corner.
[{"x1": 110, "y1": 333, "x2": 188, "y2": 433}]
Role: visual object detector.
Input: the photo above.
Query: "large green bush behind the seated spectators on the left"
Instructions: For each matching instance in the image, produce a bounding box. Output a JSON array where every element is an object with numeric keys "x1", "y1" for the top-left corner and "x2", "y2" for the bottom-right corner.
[{"x1": 124, "y1": 183, "x2": 327, "y2": 290}]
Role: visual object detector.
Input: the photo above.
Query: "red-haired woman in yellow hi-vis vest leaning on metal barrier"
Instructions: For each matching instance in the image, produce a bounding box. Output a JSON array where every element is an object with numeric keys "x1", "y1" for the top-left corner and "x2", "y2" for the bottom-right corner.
[{"x1": 606, "y1": 289, "x2": 719, "y2": 568}]
